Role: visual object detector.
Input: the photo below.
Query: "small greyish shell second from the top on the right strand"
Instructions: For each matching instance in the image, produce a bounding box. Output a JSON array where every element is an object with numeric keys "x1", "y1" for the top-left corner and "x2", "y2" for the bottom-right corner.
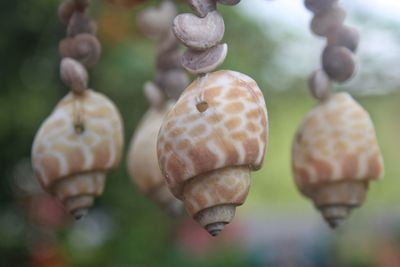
[{"x1": 311, "y1": 5, "x2": 346, "y2": 36}]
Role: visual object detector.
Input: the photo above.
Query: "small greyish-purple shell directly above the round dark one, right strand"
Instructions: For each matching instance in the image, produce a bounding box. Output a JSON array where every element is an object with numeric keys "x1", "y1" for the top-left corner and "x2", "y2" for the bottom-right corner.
[{"x1": 327, "y1": 26, "x2": 360, "y2": 53}]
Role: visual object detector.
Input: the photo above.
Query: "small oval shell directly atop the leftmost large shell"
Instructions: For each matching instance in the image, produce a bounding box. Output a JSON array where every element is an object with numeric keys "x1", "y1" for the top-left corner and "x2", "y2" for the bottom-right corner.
[{"x1": 60, "y1": 57, "x2": 89, "y2": 94}]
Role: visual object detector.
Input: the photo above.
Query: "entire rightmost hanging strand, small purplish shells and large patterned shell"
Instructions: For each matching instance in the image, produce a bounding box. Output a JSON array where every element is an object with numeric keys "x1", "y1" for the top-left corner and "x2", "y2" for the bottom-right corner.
[{"x1": 292, "y1": 0, "x2": 383, "y2": 228}]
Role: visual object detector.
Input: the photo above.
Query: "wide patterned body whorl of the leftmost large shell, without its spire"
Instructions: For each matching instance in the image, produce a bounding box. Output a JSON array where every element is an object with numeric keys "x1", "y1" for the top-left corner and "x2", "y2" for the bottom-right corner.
[{"x1": 32, "y1": 90, "x2": 123, "y2": 189}]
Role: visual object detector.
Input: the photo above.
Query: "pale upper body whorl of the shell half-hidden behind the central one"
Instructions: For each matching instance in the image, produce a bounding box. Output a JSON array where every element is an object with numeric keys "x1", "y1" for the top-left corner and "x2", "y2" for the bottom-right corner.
[{"x1": 127, "y1": 102, "x2": 173, "y2": 193}]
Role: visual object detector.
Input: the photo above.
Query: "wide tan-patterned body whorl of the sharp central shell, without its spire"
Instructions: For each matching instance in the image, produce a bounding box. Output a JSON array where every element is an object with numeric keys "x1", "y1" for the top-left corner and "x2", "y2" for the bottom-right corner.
[{"x1": 157, "y1": 71, "x2": 268, "y2": 198}]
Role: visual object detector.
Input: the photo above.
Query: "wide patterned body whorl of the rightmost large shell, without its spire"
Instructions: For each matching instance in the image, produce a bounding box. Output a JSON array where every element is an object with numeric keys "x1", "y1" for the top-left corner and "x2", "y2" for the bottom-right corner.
[{"x1": 292, "y1": 93, "x2": 383, "y2": 194}]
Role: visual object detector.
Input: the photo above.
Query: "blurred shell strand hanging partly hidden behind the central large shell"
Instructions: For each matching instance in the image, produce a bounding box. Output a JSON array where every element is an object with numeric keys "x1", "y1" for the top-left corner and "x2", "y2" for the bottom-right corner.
[{"x1": 127, "y1": 1, "x2": 188, "y2": 215}]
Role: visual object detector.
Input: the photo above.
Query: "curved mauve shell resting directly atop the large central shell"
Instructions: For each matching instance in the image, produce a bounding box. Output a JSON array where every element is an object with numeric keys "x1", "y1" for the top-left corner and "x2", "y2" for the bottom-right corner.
[{"x1": 182, "y1": 44, "x2": 228, "y2": 74}]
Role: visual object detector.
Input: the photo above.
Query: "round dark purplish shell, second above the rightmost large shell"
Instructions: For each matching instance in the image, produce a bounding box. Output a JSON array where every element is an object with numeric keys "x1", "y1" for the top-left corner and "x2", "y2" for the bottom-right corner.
[{"x1": 322, "y1": 46, "x2": 356, "y2": 82}]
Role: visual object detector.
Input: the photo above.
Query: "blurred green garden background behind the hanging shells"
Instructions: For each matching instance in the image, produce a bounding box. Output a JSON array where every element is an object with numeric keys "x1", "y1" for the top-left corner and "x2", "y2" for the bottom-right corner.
[{"x1": 0, "y1": 0, "x2": 400, "y2": 267}]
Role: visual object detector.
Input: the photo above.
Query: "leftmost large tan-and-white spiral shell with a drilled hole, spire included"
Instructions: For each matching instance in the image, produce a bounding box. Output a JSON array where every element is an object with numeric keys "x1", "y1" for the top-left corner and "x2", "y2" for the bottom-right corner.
[{"x1": 32, "y1": 90, "x2": 123, "y2": 219}]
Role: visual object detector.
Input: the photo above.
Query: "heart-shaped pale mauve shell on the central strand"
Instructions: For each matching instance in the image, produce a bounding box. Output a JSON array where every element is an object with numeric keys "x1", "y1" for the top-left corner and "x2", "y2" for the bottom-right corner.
[{"x1": 172, "y1": 11, "x2": 225, "y2": 50}]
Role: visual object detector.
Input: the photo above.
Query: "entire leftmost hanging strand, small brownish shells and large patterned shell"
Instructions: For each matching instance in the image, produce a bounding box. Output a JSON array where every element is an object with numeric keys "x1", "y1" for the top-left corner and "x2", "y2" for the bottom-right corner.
[{"x1": 32, "y1": 0, "x2": 123, "y2": 219}]
